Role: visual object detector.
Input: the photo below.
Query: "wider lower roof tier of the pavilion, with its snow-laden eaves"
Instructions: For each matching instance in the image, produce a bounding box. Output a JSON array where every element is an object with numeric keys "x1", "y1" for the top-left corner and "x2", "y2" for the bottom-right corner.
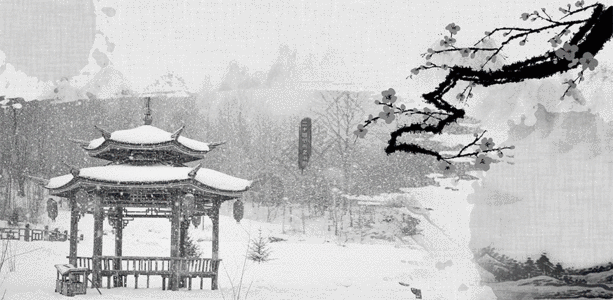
[{"x1": 45, "y1": 164, "x2": 252, "y2": 197}]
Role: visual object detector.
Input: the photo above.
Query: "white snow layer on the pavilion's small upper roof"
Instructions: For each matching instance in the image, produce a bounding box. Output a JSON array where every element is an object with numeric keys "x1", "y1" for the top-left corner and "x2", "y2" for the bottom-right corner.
[{"x1": 87, "y1": 125, "x2": 210, "y2": 151}]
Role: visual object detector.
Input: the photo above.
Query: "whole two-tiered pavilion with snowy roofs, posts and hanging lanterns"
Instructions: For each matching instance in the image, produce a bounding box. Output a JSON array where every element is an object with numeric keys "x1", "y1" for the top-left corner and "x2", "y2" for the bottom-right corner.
[{"x1": 45, "y1": 99, "x2": 252, "y2": 290}]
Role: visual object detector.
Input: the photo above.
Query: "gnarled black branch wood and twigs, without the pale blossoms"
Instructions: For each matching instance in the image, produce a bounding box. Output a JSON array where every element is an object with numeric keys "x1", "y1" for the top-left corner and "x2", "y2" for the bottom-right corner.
[{"x1": 364, "y1": 4, "x2": 613, "y2": 160}]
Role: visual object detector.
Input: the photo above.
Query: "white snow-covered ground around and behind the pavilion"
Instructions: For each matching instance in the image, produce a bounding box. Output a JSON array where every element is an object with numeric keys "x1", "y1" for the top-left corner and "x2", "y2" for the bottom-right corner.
[{"x1": 0, "y1": 197, "x2": 496, "y2": 300}]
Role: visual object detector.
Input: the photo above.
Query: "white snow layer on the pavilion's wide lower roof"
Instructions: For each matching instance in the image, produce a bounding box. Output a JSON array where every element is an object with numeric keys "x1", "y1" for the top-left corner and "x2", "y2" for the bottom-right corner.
[{"x1": 47, "y1": 165, "x2": 251, "y2": 191}]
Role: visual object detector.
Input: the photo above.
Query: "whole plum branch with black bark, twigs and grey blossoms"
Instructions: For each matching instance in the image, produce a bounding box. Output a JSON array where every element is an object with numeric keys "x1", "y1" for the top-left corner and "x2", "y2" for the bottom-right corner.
[{"x1": 356, "y1": 1, "x2": 613, "y2": 168}]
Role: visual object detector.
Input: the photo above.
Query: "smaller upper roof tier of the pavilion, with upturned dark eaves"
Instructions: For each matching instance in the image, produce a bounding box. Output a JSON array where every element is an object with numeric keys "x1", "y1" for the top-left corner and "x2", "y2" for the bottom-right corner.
[{"x1": 80, "y1": 125, "x2": 222, "y2": 163}]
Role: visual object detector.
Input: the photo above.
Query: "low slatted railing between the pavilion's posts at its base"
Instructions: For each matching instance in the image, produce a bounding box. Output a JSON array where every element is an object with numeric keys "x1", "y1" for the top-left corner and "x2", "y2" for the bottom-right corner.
[{"x1": 71, "y1": 256, "x2": 221, "y2": 289}]
